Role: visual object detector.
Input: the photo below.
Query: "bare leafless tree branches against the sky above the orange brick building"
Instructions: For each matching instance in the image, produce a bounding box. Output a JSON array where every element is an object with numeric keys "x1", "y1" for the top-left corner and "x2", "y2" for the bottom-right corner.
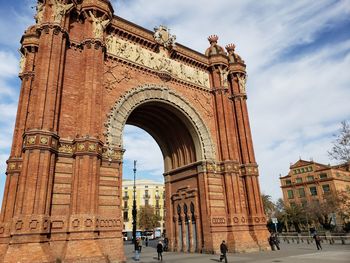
[{"x1": 328, "y1": 121, "x2": 350, "y2": 162}]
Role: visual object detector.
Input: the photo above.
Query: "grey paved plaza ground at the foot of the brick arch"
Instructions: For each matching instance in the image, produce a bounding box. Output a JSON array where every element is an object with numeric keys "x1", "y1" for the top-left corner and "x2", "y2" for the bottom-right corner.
[{"x1": 125, "y1": 242, "x2": 350, "y2": 263}]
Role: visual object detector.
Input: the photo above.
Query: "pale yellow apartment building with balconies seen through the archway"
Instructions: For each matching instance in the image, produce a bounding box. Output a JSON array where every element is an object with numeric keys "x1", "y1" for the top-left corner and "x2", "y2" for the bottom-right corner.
[{"x1": 122, "y1": 180, "x2": 165, "y2": 232}]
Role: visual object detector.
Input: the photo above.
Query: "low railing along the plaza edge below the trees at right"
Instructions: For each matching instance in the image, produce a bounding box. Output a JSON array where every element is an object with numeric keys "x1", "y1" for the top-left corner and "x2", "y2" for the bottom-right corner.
[{"x1": 279, "y1": 235, "x2": 350, "y2": 245}]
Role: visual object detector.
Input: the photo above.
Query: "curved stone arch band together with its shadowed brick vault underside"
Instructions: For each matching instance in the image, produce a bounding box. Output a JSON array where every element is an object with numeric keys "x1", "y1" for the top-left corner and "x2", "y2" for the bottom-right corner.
[{"x1": 106, "y1": 85, "x2": 215, "y2": 171}]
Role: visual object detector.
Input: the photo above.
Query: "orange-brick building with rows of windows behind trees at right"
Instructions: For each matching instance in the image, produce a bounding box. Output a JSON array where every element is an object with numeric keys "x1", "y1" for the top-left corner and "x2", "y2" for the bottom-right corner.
[{"x1": 280, "y1": 160, "x2": 350, "y2": 212}]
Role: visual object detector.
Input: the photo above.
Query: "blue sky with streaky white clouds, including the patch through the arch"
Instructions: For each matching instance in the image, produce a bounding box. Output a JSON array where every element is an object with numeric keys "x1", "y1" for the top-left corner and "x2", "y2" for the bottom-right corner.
[{"x1": 0, "y1": 0, "x2": 350, "y2": 204}]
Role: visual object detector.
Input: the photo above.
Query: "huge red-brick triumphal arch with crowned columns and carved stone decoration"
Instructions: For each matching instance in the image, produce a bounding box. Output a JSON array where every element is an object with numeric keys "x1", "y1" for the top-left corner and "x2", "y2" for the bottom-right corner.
[{"x1": 0, "y1": 0, "x2": 267, "y2": 263}]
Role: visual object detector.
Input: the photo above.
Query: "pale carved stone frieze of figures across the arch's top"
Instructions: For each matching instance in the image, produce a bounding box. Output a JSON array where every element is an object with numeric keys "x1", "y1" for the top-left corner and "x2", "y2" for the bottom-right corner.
[{"x1": 106, "y1": 35, "x2": 209, "y2": 88}]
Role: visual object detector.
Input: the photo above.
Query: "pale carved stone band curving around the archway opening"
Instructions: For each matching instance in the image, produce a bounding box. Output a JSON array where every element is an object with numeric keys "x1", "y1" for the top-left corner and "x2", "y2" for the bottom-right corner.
[{"x1": 105, "y1": 84, "x2": 215, "y2": 161}]
